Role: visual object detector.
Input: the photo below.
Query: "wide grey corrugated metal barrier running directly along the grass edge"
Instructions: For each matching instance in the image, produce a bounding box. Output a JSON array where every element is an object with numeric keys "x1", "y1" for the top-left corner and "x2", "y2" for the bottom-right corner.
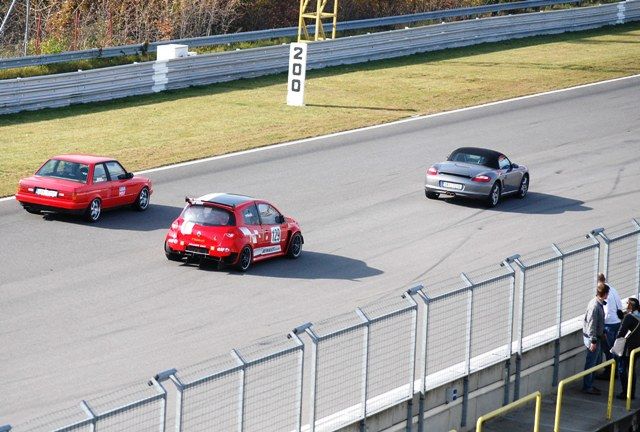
[{"x1": 0, "y1": 0, "x2": 640, "y2": 114}]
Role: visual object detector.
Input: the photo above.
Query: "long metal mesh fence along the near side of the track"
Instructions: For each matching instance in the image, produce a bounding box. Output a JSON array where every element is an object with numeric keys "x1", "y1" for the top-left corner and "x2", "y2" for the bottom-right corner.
[{"x1": 8, "y1": 220, "x2": 640, "y2": 432}]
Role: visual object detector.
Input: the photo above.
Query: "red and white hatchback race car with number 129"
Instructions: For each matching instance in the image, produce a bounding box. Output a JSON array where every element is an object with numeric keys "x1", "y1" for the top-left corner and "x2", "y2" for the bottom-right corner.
[{"x1": 164, "y1": 193, "x2": 304, "y2": 272}]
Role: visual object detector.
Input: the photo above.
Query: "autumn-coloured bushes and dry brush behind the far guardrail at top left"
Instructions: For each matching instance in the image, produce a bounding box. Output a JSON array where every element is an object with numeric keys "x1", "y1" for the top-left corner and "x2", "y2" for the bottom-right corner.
[{"x1": 0, "y1": 0, "x2": 470, "y2": 56}]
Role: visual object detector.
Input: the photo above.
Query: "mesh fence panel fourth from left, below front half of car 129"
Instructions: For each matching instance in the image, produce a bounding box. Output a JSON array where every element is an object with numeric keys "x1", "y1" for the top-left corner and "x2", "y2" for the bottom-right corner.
[{"x1": 238, "y1": 335, "x2": 302, "y2": 432}]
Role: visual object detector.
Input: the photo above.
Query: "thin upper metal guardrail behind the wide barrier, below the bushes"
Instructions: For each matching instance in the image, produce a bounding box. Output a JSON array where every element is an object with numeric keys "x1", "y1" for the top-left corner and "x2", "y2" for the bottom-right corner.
[{"x1": 0, "y1": 0, "x2": 580, "y2": 69}]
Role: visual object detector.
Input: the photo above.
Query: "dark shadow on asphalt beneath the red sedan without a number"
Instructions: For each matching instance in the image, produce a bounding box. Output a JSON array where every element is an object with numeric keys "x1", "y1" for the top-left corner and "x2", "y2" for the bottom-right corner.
[{"x1": 43, "y1": 204, "x2": 182, "y2": 231}]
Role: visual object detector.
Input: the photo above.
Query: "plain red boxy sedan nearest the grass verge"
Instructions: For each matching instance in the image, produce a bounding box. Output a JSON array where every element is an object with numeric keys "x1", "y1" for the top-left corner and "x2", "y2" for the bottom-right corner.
[{"x1": 16, "y1": 155, "x2": 153, "y2": 222}]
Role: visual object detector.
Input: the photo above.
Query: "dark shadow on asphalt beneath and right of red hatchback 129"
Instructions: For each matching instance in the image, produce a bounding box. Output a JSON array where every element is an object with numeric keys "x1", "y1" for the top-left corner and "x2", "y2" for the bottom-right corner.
[{"x1": 191, "y1": 251, "x2": 383, "y2": 281}]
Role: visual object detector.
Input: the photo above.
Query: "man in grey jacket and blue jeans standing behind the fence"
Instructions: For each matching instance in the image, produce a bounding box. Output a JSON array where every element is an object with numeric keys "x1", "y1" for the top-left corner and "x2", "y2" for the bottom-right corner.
[{"x1": 582, "y1": 282, "x2": 609, "y2": 395}]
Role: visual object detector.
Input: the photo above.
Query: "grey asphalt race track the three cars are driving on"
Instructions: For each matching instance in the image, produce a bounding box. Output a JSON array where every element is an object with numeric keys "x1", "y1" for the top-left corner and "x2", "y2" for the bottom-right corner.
[{"x1": 0, "y1": 76, "x2": 640, "y2": 425}]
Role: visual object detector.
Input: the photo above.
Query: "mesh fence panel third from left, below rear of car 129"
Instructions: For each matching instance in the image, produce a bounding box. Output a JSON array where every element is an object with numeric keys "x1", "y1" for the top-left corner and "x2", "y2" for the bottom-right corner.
[{"x1": 176, "y1": 355, "x2": 242, "y2": 432}]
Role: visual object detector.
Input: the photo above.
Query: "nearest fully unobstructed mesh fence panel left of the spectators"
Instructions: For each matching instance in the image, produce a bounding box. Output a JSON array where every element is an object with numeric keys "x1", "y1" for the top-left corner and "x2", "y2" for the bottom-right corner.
[{"x1": 516, "y1": 257, "x2": 560, "y2": 351}]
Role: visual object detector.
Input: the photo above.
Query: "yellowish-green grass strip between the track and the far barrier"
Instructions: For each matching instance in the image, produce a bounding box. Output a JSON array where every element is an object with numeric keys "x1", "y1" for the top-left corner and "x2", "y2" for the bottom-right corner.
[{"x1": 0, "y1": 23, "x2": 640, "y2": 196}]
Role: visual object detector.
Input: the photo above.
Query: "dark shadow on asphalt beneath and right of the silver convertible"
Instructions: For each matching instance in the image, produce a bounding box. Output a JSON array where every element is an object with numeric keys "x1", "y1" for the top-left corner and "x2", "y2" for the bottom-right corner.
[{"x1": 443, "y1": 192, "x2": 593, "y2": 214}]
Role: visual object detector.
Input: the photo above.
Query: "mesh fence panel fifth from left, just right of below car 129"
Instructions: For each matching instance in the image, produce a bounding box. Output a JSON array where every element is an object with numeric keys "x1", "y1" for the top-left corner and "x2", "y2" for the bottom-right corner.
[{"x1": 314, "y1": 313, "x2": 366, "y2": 431}]
